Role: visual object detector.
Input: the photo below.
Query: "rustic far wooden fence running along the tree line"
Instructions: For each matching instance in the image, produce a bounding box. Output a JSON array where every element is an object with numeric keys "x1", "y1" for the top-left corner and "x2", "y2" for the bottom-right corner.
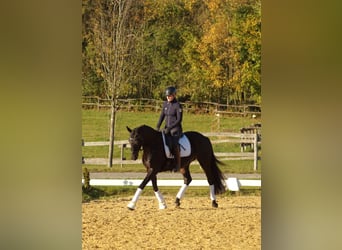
[{"x1": 82, "y1": 96, "x2": 261, "y2": 117}]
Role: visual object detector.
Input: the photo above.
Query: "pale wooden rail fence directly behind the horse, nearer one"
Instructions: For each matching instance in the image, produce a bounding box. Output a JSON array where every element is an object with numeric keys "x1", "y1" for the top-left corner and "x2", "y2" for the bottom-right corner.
[{"x1": 82, "y1": 132, "x2": 260, "y2": 171}]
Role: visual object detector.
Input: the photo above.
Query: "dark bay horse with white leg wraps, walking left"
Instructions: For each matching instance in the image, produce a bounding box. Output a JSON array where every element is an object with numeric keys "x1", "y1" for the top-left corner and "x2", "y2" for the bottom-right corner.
[{"x1": 127, "y1": 125, "x2": 226, "y2": 210}]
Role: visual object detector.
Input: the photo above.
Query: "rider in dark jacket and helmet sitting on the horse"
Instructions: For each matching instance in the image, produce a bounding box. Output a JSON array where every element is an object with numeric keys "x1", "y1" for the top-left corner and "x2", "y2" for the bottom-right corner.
[{"x1": 157, "y1": 86, "x2": 183, "y2": 172}]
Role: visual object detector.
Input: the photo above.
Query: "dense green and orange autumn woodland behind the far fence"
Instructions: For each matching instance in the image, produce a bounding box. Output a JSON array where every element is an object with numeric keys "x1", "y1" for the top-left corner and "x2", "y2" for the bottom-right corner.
[{"x1": 82, "y1": 0, "x2": 261, "y2": 104}]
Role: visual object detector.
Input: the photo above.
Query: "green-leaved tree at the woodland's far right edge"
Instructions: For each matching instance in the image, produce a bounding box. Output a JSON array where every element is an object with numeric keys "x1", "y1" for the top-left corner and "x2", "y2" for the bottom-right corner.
[{"x1": 229, "y1": 0, "x2": 261, "y2": 103}]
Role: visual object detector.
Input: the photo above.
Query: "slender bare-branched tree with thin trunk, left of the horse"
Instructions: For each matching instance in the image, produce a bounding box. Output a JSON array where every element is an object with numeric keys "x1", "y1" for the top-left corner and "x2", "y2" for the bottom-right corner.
[{"x1": 89, "y1": 0, "x2": 134, "y2": 167}]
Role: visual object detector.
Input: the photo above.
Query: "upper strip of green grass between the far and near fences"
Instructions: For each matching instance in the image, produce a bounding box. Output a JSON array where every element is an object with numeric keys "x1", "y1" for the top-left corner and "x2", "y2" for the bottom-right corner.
[{"x1": 82, "y1": 110, "x2": 260, "y2": 141}]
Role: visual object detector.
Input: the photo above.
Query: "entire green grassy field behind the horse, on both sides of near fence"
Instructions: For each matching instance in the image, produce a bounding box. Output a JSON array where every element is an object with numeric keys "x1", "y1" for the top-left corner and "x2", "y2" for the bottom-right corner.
[{"x1": 82, "y1": 110, "x2": 261, "y2": 173}]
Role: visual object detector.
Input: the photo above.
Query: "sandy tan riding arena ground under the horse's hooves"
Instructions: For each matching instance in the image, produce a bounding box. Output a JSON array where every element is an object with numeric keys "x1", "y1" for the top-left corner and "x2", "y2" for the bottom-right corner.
[{"x1": 82, "y1": 195, "x2": 261, "y2": 250}]
